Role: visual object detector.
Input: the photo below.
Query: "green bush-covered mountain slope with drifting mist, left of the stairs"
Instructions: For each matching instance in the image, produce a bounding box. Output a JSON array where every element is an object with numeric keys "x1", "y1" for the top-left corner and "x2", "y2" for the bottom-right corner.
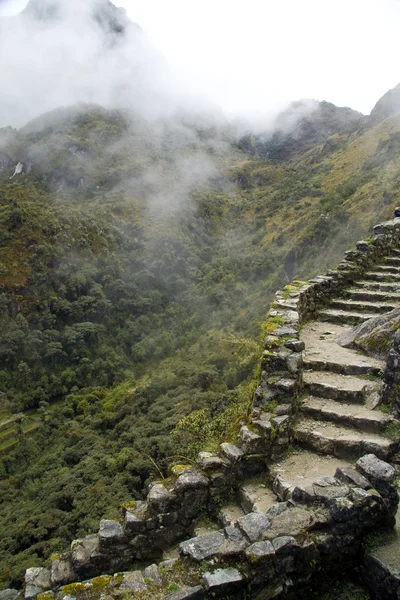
[{"x1": 0, "y1": 102, "x2": 400, "y2": 586}]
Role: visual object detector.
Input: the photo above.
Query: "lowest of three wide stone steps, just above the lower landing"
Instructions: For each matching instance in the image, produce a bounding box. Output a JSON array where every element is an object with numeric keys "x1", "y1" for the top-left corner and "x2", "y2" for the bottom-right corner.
[{"x1": 294, "y1": 418, "x2": 398, "y2": 460}]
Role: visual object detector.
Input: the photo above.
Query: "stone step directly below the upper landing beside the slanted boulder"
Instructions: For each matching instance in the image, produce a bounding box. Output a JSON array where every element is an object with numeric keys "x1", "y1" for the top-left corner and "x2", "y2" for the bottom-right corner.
[{"x1": 303, "y1": 371, "x2": 373, "y2": 403}]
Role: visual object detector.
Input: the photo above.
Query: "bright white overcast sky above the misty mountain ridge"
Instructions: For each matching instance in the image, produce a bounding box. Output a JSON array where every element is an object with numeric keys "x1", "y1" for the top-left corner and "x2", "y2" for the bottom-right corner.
[{"x1": 0, "y1": 0, "x2": 400, "y2": 115}]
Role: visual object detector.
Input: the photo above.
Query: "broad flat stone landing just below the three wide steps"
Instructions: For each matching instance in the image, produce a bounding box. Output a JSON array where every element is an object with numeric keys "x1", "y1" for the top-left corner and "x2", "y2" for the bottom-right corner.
[{"x1": 271, "y1": 447, "x2": 350, "y2": 501}]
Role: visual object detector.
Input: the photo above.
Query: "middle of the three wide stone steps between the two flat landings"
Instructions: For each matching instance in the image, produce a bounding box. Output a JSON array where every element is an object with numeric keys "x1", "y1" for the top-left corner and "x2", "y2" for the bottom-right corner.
[{"x1": 301, "y1": 396, "x2": 392, "y2": 432}]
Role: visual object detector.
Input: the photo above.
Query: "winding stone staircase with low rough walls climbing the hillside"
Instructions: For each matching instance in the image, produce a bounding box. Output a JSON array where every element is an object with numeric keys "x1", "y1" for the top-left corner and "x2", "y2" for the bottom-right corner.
[{"x1": 17, "y1": 226, "x2": 400, "y2": 600}]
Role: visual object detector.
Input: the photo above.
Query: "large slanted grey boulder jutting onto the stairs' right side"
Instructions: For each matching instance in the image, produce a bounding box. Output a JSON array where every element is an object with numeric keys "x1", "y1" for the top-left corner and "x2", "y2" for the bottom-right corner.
[{"x1": 339, "y1": 308, "x2": 400, "y2": 359}]
